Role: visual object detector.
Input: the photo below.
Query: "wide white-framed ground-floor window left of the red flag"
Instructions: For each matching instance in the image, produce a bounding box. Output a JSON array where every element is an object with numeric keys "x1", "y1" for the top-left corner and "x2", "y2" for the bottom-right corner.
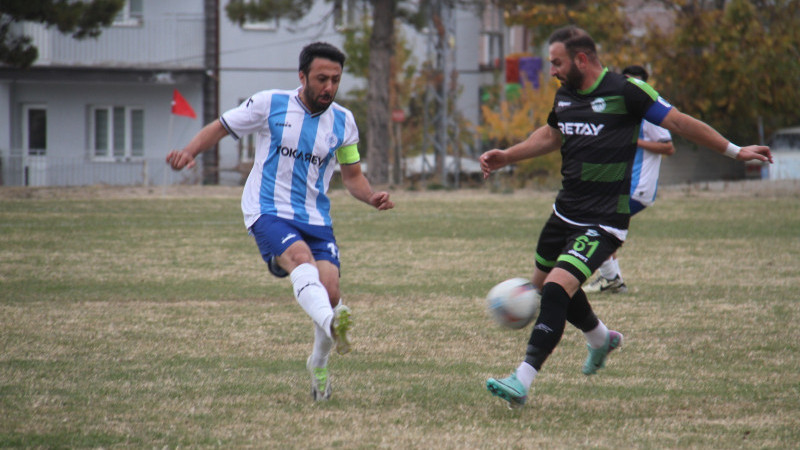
[{"x1": 89, "y1": 106, "x2": 144, "y2": 160}]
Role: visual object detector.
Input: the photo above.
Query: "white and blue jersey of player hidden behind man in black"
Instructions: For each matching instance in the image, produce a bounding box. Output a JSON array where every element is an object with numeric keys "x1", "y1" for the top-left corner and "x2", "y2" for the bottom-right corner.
[{"x1": 631, "y1": 120, "x2": 672, "y2": 206}]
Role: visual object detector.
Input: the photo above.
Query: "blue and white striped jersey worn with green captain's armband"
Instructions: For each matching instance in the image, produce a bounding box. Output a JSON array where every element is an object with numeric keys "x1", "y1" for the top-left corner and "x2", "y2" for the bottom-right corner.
[{"x1": 220, "y1": 88, "x2": 359, "y2": 229}]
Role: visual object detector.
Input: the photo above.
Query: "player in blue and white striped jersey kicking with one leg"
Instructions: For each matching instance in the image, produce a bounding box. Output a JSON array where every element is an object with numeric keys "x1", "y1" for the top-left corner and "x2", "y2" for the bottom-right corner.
[{"x1": 167, "y1": 42, "x2": 394, "y2": 401}]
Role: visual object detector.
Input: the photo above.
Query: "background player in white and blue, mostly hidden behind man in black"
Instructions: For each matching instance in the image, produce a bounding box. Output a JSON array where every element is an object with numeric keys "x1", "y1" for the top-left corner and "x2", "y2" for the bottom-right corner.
[{"x1": 583, "y1": 66, "x2": 675, "y2": 294}]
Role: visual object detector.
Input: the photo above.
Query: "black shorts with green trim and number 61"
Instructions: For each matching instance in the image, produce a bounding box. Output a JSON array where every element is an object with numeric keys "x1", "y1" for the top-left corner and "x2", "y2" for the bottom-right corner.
[{"x1": 536, "y1": 213, "x2": 622, "y2": 283}]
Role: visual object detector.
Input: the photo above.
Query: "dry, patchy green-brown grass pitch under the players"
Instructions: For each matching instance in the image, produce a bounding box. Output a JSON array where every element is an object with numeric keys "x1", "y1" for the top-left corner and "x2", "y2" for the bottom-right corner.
[{"x1": 0, "y1": 188, "x2": 800, "y2": 449}]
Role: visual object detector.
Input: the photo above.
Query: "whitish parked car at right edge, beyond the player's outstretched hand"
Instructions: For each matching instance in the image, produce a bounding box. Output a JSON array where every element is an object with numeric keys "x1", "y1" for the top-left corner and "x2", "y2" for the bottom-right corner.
[{"x1": 745, "y1": 126, "x2": 800, "y2": 180}]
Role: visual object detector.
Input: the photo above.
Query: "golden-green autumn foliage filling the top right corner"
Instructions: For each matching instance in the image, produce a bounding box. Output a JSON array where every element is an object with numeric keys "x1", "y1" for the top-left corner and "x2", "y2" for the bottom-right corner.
[{"x1": 496, "y1": 0, "x2": 800, "y2": 143}]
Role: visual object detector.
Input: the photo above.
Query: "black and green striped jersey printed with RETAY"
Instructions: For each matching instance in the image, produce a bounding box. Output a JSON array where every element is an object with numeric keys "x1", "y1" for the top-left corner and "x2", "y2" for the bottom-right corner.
[{"x1": 547, "y1": 69, "x2": 672, "y2": 240}]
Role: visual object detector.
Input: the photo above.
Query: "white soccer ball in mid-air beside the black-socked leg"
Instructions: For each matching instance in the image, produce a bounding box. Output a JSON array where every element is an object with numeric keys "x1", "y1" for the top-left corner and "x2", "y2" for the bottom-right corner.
[{"x1": 486, "y1": 278, "x2": 542, "y2": 330}]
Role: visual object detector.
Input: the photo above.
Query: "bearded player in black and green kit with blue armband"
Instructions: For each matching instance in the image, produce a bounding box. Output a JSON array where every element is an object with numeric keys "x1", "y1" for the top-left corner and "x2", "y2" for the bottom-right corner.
[{"x1": 480, "y1": 26, "x2": 772, "y2": 408}]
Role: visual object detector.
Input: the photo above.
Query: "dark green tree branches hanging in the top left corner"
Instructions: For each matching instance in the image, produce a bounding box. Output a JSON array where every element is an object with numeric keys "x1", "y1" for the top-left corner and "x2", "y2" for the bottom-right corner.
[{"x1": 0, "y1": 0, "x2": 125, "y2": 68}]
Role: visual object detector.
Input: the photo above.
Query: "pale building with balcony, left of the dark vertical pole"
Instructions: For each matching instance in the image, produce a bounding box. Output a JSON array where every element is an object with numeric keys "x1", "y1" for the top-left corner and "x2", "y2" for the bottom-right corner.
[{"x1": 0, "y1": 0, "x2": 205, "y2": 185}]
